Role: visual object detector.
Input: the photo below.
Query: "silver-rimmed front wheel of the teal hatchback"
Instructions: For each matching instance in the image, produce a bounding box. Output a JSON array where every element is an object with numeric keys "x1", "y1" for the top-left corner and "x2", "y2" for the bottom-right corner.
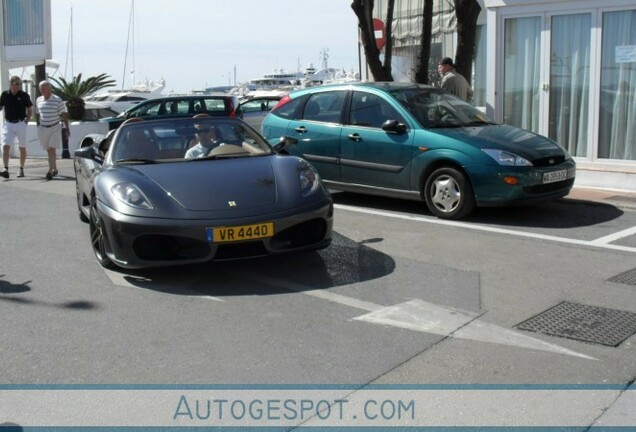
[{"x1": 424, "y1": 167, "x2": 475, "y2": 219}]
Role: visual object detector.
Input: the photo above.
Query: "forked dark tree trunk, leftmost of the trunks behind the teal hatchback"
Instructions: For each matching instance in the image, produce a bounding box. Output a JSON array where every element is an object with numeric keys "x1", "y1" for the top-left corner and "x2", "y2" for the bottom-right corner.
[{"x1": 351, "y1": 0, "x2": 395, "y2": 81}]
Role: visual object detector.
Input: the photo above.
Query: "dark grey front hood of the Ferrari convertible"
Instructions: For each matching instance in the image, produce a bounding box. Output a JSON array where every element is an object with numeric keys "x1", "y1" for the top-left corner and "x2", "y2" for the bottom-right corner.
[{"x1": 135, "y1": 157, "x2": 277, "y2": 211}]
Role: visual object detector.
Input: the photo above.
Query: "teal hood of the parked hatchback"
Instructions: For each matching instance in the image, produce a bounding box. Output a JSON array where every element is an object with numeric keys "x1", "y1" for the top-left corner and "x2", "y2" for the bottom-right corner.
[{"x1": 435, "y1": 125, "x2": 564, "y2": 160}]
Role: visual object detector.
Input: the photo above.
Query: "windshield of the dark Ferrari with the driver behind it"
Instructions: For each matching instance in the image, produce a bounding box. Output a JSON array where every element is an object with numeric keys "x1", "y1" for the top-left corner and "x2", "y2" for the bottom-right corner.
[{"x1": 110, "y1": 117, "x2": 273, "y2": 164}]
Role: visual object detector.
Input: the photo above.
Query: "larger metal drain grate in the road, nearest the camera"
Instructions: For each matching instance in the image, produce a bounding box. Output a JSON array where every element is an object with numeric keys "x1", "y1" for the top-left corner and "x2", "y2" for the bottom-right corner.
[{"x1": 514, "y1": 301, "x2": 636, "y2": 347}]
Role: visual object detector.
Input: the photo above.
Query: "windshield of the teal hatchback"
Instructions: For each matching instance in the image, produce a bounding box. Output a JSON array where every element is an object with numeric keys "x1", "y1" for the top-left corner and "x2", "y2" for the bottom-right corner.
[{"x1": 391, "y1": 88, "x2": 493, "y2": 128}]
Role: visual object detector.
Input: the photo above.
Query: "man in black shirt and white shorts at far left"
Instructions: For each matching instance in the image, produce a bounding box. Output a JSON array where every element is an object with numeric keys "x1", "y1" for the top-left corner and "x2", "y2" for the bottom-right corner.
[{"x1": 0, "y1": 76, "x2": 33, "y2": 178}]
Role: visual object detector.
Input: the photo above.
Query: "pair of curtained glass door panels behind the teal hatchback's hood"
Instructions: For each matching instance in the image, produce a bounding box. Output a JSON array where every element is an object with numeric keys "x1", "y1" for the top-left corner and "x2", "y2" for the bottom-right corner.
[{"x1": 503, "y1": 13, "x2": 592, "y2": 156}]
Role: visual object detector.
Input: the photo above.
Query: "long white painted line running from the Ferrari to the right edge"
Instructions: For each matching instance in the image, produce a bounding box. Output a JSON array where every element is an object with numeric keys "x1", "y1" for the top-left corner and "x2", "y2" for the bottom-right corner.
[{"x1": 334, "y1": 204, "x2": 636, "y2": 253}]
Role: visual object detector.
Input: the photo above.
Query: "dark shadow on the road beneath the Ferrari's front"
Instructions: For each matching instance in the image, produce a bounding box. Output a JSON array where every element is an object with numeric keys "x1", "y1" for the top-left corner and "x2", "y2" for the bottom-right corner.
[{"x1": 112, "y1": 232, "x2": 395, "y2": 296}]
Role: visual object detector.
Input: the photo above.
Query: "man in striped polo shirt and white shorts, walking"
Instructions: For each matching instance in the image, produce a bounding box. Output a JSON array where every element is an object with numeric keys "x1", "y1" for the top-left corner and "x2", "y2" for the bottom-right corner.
[{"x1": 35, "y1": 81, "x2": 71, "y2": 180}]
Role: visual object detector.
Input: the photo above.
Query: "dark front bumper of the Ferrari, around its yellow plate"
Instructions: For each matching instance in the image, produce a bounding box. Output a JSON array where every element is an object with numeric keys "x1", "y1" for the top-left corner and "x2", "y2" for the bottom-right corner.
[{"x1": 97, "y1": 200, "x2": 333, "y2": 268}]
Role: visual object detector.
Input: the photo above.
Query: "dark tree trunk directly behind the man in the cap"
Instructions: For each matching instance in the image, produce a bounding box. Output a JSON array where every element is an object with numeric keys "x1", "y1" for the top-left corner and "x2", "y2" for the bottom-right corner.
[{"x1": 454, "y1": 0, "x2": 481, "y2": 82}]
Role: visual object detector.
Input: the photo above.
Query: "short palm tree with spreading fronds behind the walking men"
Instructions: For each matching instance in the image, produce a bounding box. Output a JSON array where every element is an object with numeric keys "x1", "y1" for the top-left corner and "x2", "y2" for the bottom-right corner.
[{"x1": 50, "y1": 74, "x2": 115, "y2": 120}]
